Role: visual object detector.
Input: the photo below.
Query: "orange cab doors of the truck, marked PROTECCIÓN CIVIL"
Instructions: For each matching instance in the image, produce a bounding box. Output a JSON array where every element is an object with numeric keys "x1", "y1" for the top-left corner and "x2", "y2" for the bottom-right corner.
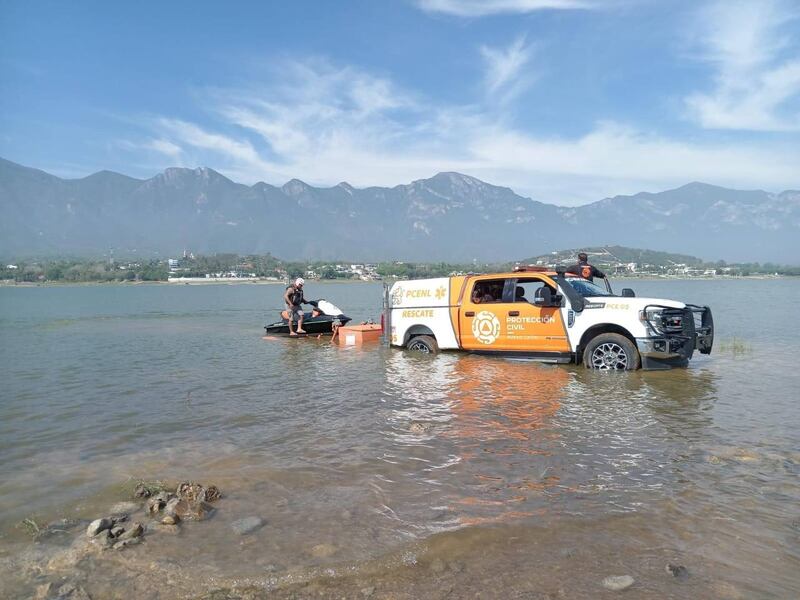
[{"x1": 459, "y1": 275, "x2": 570, "y2": 360}]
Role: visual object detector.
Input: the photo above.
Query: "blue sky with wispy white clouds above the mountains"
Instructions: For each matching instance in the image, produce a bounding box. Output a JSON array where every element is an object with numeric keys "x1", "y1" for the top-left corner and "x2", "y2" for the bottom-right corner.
[{"x1": 0, "y1": 0, "x2": 800, "y2": 205}]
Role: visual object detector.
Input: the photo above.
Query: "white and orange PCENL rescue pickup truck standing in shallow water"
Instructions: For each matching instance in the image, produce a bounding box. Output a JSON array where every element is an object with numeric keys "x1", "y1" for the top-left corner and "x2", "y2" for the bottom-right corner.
[{"x1": 383, "y1": 267, "x2": 714, "y2": 370}]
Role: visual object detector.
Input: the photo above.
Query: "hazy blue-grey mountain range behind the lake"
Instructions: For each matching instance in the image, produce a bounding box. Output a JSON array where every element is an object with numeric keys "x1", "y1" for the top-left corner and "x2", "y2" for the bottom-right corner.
[{"x1": 0, "y1": 159, "x2": 800, "y2": 264}]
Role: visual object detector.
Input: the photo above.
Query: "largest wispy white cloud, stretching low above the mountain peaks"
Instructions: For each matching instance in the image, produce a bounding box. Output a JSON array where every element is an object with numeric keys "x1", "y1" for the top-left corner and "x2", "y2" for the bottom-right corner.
[{"x1": 145, "y1": 62, "x2": 800, "y2": 205}]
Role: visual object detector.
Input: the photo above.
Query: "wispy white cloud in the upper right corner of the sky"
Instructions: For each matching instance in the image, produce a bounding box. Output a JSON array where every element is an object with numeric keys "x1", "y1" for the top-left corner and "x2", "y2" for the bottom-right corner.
[{"x1": 686, "y1": 0, "x2": 800, "y2": 131}]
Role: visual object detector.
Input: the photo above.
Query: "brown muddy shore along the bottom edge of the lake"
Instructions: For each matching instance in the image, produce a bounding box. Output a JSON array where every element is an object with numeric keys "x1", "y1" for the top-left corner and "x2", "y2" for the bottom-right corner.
[{"x1": 0, "y1": 506, "x2": 776, "y2": 600}]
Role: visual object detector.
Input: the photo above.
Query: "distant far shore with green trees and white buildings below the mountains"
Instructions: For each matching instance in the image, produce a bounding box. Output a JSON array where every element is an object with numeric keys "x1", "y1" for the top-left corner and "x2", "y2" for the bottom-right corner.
[{"x1": 0, "y1": 249, "x2": 800, "y2": 285}]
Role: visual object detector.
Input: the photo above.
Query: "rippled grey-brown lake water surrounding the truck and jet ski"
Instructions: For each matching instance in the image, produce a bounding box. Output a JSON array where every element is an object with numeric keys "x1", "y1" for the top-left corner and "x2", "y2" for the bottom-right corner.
[{"x1": 0, "y1": 279, "x2": 800, "y2": 599}]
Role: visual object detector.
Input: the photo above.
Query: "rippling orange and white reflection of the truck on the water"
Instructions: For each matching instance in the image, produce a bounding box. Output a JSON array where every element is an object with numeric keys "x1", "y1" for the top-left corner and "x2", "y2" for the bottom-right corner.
[{"x1": 385, "y1": 352, "x2": 717, "y2": 526}]
